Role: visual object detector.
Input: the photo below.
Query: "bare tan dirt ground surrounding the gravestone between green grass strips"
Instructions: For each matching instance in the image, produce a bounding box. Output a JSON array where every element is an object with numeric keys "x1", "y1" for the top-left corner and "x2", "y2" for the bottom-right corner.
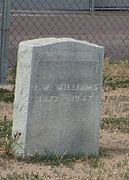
[{"x1": 0, "y1": 88, "x2": 129, "y2": 180}]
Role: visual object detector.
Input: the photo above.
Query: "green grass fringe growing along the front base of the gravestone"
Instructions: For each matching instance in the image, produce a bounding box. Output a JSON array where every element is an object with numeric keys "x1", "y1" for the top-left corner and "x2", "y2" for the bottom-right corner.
[{"x1": 17, "y1": 149, "x2": 109, "y2": 168}]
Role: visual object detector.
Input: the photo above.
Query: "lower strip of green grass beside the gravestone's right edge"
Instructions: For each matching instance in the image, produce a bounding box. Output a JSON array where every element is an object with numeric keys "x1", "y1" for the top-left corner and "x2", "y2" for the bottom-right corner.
[{"x1": 101, "y1": 117, "x2": 129, "y2": 133}]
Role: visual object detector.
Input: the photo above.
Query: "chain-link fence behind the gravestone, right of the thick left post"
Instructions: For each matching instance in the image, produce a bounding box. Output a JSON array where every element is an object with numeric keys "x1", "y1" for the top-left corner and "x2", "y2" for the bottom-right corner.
[{"x1": 9, "y1": 0, "x2": 129, "y2": 66}]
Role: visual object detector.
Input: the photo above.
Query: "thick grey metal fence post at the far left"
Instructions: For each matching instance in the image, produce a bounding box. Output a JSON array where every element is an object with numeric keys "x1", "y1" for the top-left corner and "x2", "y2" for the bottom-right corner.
[{"x1": 0, "y1": 0, "x2": 11, "y2": 84}]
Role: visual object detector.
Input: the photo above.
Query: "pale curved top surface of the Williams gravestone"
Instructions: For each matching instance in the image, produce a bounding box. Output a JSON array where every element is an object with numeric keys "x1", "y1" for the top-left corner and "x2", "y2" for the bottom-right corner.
[{"x1": 20, "y1": 38, "x2": 104, "y2": 49}]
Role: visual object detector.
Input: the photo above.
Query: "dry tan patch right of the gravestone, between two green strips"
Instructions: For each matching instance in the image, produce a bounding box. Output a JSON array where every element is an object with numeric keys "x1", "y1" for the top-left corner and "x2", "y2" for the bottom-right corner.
[{"x1": 102, "y1": 88, "x2": 129, "y2": 118}]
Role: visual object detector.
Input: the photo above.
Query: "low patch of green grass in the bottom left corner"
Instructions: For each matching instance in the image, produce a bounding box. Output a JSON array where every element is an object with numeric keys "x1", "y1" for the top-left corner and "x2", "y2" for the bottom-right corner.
[{"x1": 0, "y1": 172, "x2": 42, "y2": 180}]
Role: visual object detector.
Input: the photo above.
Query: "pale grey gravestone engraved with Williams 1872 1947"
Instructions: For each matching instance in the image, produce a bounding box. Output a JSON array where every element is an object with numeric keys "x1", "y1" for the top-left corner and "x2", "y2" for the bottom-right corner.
[{"x1": 13, "y1": 38, "x2": 104, "y2": 157}]
